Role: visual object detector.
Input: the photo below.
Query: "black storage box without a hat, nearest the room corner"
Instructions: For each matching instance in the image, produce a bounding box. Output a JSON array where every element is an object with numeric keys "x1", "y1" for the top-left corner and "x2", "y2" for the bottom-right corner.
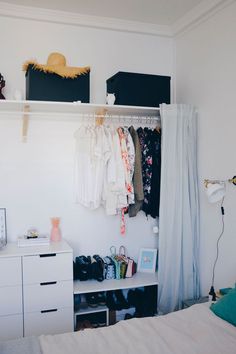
[{"x1": 107, "y1": 71, "x2": 171, "y2": 107}]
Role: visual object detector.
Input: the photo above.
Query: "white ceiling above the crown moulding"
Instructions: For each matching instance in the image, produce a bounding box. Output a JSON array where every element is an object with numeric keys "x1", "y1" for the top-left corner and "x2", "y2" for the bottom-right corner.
[{"x1": 2, "y1": 0, "x2": 204, "y2": 25}]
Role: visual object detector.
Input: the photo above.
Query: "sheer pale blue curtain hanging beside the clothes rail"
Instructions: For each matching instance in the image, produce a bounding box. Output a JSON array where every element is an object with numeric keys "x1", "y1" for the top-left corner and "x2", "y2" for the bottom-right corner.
[{"x1": 158, "y1": 104, "x2": 200, "y2": 313}]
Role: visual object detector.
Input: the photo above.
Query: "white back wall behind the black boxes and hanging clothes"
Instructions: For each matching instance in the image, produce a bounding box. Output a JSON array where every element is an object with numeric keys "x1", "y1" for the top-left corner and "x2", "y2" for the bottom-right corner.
[{"x1": 0, "y1": 17, "x2": 173, "y2": 257}]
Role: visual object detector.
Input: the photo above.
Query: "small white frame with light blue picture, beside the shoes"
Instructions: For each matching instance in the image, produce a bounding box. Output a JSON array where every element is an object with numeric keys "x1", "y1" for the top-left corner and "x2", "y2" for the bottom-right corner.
[{"x1": 137, "y1": 248, "x2": 157, "y2": 273}]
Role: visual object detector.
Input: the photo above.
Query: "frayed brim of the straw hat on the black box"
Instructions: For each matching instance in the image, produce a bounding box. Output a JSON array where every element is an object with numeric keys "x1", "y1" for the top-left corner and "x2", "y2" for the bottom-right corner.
[{"x1": 23, "y1": 61, "x2": 90, "y2": 79}]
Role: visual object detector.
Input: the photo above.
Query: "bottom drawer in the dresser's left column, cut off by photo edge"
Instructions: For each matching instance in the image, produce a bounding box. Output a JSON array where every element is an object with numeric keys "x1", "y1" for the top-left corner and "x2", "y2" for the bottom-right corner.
[{"x1": 0, "y1": 315, "x2": 23, "y2": 340}]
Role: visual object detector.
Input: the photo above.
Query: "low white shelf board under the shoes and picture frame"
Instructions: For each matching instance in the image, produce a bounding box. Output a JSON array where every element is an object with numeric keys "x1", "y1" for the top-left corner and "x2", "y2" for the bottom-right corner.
[{"x1": 74, "y1": 273, "x2": 158, "y2": 294}]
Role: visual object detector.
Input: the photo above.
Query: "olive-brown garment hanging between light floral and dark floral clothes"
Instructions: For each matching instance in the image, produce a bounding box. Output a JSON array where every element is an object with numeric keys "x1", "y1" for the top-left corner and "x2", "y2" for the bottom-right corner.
[{"x1": 129, "y1": 126, "x2": 144, "y2": 217}]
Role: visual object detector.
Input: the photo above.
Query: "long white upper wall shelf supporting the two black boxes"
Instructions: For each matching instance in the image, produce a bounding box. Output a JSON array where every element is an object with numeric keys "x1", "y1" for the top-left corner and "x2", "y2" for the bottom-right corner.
[{"x1": 0, "y1": 100, "x2": 159, "y2": 120}]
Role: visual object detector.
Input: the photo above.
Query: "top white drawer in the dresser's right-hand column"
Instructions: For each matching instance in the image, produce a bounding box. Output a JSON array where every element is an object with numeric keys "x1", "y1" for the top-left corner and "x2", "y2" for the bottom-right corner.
[{"x1": 23, "y1": 253, "x2": 73, "y2": 284}]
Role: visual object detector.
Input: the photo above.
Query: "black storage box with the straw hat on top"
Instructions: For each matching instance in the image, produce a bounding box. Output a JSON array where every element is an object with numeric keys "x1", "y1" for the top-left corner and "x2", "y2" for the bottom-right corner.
[{"x1": 25, "y1": 65, "x2": 89, "y2": 103}]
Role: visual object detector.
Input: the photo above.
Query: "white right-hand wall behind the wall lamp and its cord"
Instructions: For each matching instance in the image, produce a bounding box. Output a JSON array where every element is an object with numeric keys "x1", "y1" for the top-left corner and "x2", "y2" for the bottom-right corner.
[{"x1": 176, "y1": 2, "x2": 236, "y2": 292}]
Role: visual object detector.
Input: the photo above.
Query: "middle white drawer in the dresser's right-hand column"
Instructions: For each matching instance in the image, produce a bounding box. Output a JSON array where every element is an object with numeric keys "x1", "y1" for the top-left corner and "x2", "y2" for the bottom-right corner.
[{"x1": 24, "y1": 280, "x2": 73, "y2": 312}]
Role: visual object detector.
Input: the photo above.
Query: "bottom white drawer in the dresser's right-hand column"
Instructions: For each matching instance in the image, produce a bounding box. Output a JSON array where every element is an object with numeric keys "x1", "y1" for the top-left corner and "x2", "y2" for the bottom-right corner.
[{"x1": 24, "y1": 307, "x2": 73, "y2": 336}]
